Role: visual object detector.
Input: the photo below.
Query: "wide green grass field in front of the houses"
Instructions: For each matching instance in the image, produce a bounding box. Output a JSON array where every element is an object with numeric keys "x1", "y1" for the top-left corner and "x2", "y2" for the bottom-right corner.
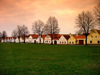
[{"x1": 0, "y1": 43, "x2": 100, "y2": 75}]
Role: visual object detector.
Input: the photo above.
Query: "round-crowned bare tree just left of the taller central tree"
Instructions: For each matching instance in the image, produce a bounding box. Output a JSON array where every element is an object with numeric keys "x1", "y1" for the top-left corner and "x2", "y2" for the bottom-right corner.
[{"x1": 32, "y1": 20, "x2": 44, "y2": 44}]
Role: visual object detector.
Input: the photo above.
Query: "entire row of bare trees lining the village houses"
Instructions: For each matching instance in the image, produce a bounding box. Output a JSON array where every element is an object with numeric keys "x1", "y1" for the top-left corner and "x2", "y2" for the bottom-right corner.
[{"x1": 0, "y1": 3, "x2": 100, "y2": 45}]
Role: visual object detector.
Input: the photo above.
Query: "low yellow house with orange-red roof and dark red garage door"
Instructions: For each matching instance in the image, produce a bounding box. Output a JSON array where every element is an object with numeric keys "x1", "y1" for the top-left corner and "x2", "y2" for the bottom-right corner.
[{"x1": 68, "y1": 35, "x2": 86, "y2": 45}]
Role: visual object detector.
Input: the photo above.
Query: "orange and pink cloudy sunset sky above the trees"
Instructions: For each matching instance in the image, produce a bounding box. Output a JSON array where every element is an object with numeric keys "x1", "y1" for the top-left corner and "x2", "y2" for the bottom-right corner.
[{"x1": 0, "y1": 0, "x2": 99, "y2": 36}]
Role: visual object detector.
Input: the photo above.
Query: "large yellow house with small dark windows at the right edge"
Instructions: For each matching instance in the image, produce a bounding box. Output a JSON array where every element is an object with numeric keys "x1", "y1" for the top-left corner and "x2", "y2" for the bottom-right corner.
[{"x1": 87, "y1": 29, "x2": 100, "y2": 44}]
